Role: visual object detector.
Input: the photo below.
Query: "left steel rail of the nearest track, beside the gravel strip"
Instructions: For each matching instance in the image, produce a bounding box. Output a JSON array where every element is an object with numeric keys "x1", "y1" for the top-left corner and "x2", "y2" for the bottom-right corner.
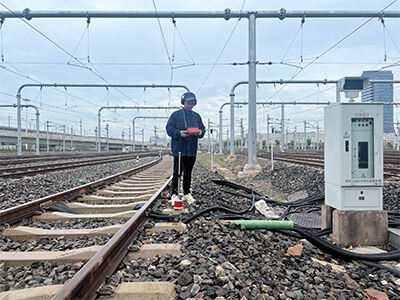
[{"x1": 0, "y1": 158, "x2": 161, "y2": 224}]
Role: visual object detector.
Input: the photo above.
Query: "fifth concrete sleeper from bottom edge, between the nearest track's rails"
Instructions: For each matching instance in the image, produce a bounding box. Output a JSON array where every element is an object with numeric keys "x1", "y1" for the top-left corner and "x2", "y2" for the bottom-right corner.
[{"x1": 68, "y1": 201, "x2": 146, "y2": 214}]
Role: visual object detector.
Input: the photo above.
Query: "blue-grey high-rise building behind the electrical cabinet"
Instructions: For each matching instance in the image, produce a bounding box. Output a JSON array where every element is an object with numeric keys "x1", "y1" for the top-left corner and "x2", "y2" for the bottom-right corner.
[{"x1": 361, "y1": 71, "x2": 394, "y2": 132}]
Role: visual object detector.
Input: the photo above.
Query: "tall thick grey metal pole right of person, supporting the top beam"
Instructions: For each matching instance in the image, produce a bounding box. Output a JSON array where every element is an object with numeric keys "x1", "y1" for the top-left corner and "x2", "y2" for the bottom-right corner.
[{"x1": 247, "y1": 13, "x2": 257, "y2": 165}]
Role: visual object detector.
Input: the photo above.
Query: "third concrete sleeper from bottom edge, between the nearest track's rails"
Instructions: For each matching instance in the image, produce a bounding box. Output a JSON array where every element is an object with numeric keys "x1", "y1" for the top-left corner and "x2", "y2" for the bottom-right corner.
[{"x1": 1, "y1": 225, "x2": 122, "y2": 240}]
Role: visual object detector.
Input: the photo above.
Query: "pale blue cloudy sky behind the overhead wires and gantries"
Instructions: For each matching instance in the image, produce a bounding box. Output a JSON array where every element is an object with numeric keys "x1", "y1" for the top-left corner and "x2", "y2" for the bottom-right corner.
[{"x1": 0, "y1": 0, "x2": 400, "y2": 140}]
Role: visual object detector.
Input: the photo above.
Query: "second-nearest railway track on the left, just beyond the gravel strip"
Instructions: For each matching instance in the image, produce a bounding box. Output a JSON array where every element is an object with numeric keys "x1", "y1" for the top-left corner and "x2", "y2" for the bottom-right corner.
[{"x1": 0, "y1": 152, "x2": 166, "y2": 178}]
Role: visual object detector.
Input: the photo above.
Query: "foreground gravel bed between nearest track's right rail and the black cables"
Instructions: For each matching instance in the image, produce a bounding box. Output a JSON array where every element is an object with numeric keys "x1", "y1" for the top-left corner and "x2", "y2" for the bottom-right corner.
[{"x1": 103, "y1": 165, "x2": 400, "y2": 300}]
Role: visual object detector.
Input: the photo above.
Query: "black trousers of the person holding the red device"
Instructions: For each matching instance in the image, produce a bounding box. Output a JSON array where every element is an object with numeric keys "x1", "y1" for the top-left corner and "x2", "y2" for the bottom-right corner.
[{"x1": 171, "y1": 156, "x2": 196, "y2": 195}]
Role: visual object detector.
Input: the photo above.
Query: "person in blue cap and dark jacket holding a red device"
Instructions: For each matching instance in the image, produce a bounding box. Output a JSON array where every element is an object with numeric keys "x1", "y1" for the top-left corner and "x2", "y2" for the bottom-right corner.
[{"x1": 166, "y1": 92, "x2": 206, "y2": 203}]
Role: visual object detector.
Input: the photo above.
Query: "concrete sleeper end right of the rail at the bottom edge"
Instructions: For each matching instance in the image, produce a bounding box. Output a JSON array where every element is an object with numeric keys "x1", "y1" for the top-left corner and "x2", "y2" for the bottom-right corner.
[{"x1": 100, "y1": 281, "x2": 176, "y2": 300}]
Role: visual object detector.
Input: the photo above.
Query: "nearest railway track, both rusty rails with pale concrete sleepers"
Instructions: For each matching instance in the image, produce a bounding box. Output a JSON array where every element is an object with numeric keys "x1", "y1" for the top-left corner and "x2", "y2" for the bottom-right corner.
[{"x1": 0, "y1": 158, "x2": 182, "y2": 299}]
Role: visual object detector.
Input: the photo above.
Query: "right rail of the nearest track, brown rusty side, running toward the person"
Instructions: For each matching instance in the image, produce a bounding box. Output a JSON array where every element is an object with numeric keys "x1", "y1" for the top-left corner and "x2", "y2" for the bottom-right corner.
[{"x1": 52, "y1": 176, "x2": 172, "y2": 300}]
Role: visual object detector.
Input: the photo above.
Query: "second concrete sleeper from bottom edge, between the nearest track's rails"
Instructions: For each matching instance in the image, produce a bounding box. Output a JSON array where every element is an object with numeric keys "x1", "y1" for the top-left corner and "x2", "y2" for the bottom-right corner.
[{"x1": 0, "y1": 245, "x2": 102, "y2": 266}]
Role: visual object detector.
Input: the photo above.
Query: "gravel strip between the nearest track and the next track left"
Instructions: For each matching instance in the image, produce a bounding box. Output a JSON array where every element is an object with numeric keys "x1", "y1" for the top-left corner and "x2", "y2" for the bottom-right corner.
[{"x1": 0, "y1": 157, "x2": 156, "y2": 210}]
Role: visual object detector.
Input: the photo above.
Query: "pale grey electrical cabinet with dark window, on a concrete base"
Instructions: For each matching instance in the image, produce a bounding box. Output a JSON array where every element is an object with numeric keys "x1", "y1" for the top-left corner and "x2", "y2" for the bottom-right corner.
[{"x1": 324, "y1": 102, "x2": 383, "y2": 210}]
